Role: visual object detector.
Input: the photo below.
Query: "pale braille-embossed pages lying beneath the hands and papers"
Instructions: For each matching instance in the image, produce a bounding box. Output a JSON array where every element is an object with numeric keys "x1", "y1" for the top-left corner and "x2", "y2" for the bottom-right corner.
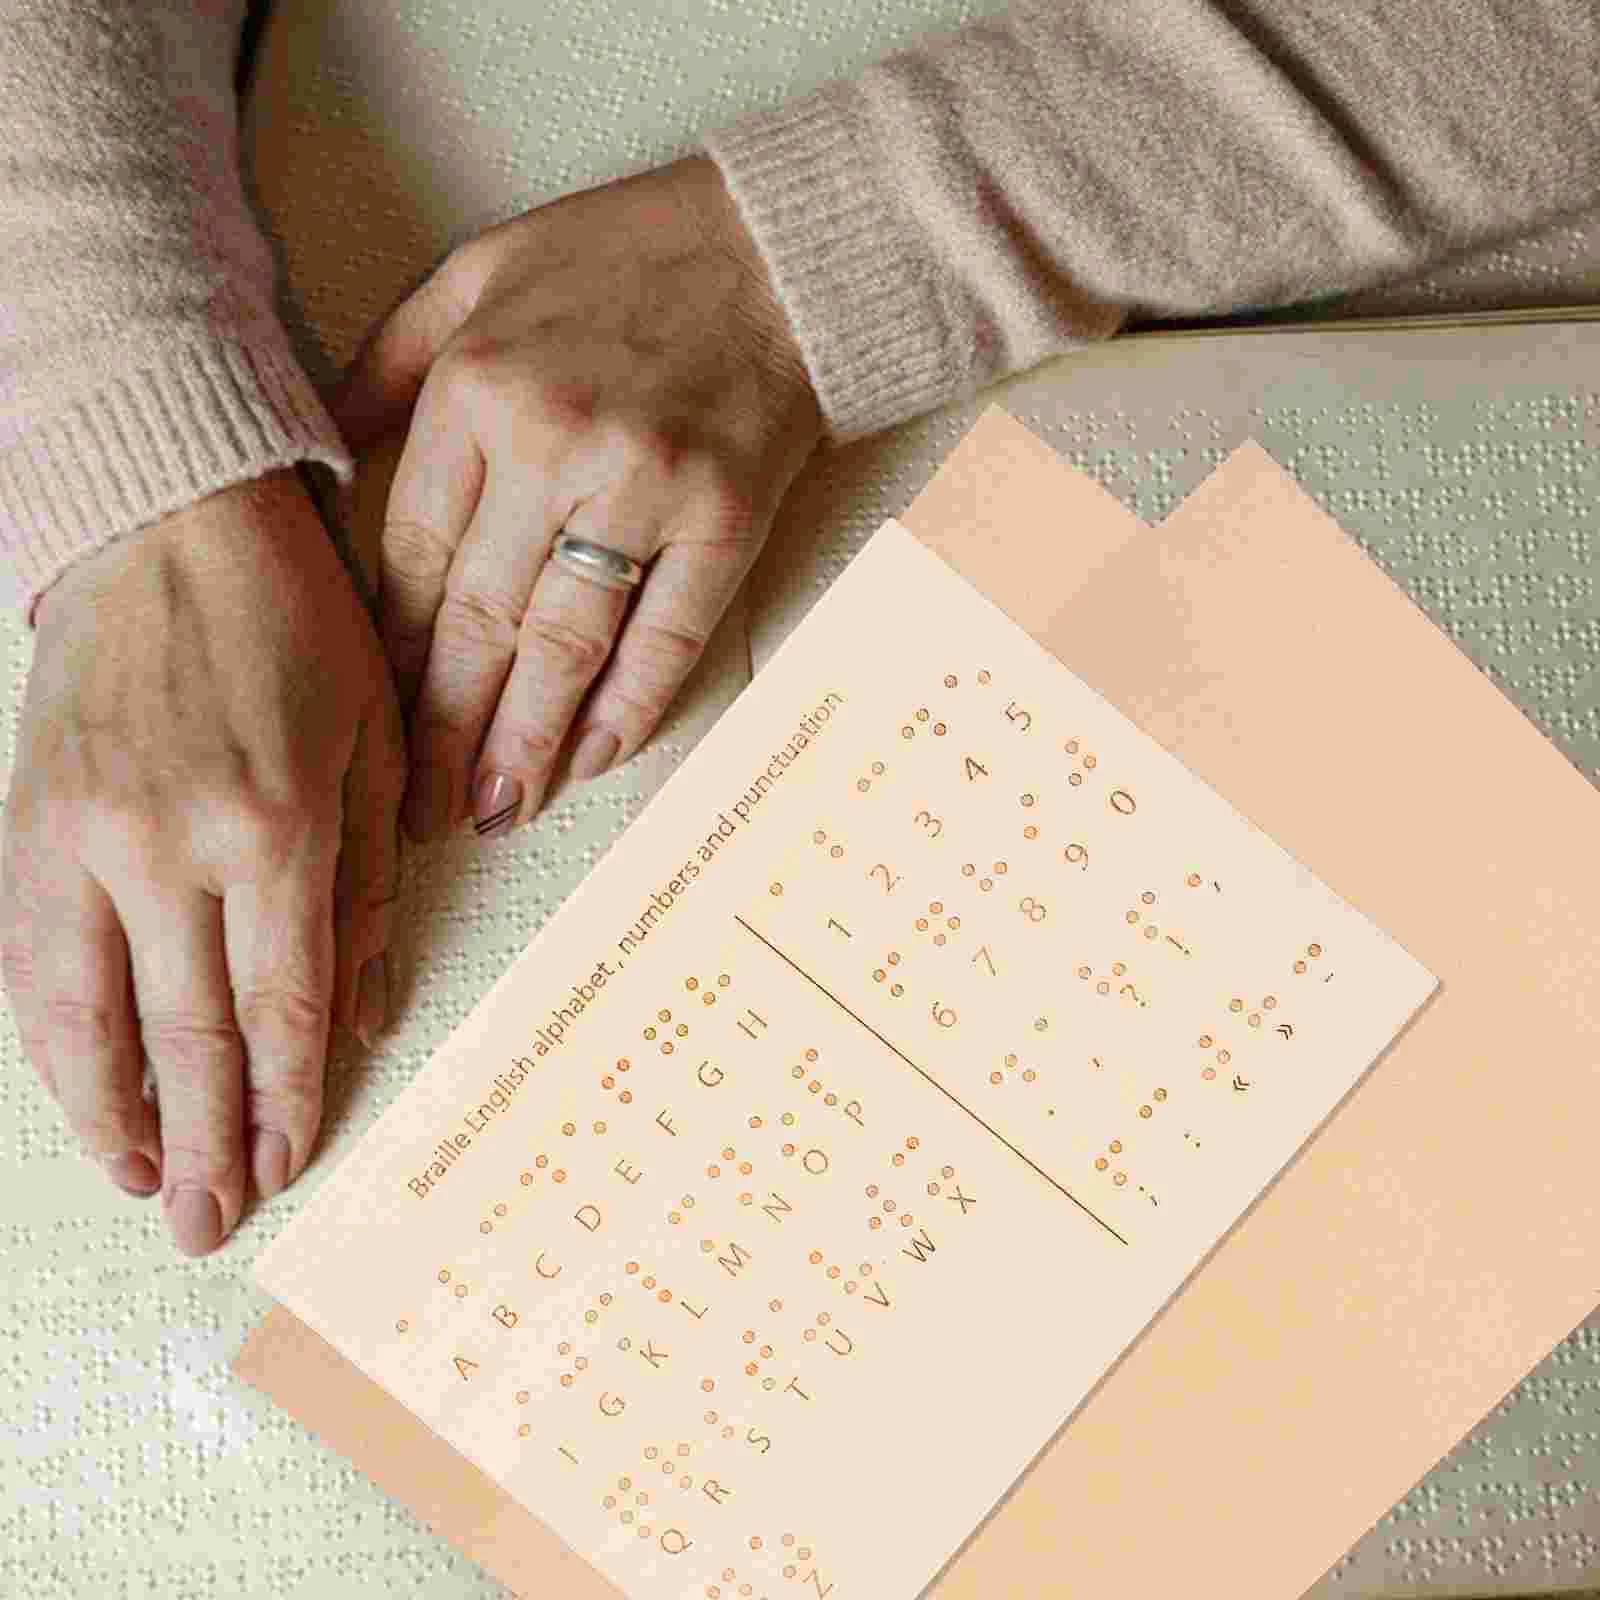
[{"x1": 0, "y1": 0, "x2": 1600, "y2": 1600}]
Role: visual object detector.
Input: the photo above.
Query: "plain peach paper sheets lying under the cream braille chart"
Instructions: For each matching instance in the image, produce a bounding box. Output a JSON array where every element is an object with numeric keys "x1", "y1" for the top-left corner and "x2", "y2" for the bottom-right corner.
[{"x1": 240, "y1": 411, "x2": 1600, "y2": 1595}]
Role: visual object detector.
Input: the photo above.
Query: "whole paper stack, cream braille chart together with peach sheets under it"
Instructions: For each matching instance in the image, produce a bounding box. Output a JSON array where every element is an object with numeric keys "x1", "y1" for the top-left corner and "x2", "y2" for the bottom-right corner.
[{"x1": 238, "y1": 411, "x2": 1600, "y2": 1600}]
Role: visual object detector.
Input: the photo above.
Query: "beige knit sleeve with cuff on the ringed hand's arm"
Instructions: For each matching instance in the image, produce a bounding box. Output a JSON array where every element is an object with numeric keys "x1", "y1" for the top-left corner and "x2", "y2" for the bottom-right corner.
[{"x1": 699, "y1": 0, "x2": 1600, "y2": 440}]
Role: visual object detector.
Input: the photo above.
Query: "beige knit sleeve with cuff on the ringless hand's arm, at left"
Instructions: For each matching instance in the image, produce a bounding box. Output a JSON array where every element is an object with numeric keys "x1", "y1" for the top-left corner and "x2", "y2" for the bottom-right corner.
[{"x1": 0, "y1": 0, "x2": 355, "y2": 626}]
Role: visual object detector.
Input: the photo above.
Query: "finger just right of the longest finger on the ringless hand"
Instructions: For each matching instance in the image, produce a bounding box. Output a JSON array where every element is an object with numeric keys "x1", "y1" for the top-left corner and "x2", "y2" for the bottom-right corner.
[{"x1": 224, "y1": 812, "x2": 339, "y2": 1200}]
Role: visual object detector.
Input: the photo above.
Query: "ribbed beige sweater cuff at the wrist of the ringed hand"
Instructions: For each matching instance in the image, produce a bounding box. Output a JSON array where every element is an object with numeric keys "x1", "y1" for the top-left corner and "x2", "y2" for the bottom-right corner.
[{"x1": 701, "y1": 83, "x2": 966, "y2": 442}]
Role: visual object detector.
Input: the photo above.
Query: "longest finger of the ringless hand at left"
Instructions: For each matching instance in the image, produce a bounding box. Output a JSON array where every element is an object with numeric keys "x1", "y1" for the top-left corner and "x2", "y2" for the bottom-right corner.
[{"x1": 110, "y1": 872, "x2": 245, "y2": 1256}]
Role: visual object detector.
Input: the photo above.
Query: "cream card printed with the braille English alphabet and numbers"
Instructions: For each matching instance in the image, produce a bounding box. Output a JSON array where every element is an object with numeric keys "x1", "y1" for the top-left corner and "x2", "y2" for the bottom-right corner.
[{"x1": 258, "y1": 486, "x2": 1435, "y2": 1600}]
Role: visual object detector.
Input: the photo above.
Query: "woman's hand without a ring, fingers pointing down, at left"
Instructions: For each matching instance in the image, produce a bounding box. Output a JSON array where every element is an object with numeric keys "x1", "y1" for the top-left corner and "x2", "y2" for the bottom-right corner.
[{"x1": 0, "y1": 469, "x2": 405, "y2": 1254}]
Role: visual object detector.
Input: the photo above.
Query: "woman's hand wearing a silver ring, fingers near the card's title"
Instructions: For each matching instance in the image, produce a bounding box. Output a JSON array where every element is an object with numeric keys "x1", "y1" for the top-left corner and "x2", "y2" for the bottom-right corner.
[{"x1": 330, "y1": 157, "x2": 822, "y2": 840}]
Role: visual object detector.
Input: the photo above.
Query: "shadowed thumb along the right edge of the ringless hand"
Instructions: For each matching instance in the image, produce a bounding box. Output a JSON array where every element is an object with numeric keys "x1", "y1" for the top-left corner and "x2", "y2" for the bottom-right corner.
[{"x1": 333, "y1": 693, "x2": 405, "y2": 1046}]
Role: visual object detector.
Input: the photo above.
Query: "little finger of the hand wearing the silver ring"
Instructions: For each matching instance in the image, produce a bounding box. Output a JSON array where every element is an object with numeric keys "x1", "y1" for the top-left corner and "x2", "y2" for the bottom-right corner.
[{"x1": 544, "y1": 469, "x2": 770, "y2": 781}]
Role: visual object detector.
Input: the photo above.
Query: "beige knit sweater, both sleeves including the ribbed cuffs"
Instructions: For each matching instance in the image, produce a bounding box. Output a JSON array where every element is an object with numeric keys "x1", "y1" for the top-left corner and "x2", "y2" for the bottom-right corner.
[{"x1": 0, "y1": 0, "x2": 1600, "y2": 624}]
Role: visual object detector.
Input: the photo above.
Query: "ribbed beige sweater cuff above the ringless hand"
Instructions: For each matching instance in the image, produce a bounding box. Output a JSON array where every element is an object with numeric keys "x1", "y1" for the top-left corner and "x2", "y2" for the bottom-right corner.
[{"x1": 0, "y1": 323, "x2": 355, "y2": 627}]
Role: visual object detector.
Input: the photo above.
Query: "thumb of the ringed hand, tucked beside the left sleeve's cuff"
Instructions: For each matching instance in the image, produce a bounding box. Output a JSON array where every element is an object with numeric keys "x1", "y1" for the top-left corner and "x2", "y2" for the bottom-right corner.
[{"x1": 326, "y1": 240, "x2": 482, "y2": 454}]
